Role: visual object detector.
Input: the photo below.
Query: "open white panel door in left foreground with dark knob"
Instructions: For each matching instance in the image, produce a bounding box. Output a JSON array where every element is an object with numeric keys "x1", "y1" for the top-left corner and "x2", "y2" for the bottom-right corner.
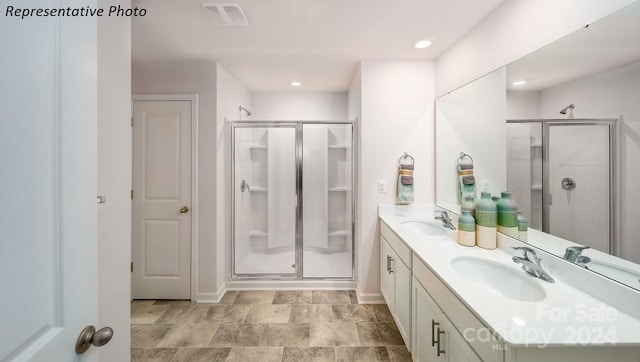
[{"x1": 0, "y1": 0, "x2": 102, "y2": 362}]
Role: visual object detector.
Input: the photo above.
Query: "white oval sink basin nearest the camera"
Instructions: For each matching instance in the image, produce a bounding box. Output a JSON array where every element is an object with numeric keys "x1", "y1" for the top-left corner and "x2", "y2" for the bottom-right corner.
[{"x1": 451, "y1": 256, "x2": 547, "y2": 302}]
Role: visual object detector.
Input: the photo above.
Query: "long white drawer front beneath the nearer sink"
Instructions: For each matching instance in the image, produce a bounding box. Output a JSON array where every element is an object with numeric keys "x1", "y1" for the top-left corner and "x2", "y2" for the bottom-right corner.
[{"x1": 413, "y1": 255, "x2": 504, "y2": 362}]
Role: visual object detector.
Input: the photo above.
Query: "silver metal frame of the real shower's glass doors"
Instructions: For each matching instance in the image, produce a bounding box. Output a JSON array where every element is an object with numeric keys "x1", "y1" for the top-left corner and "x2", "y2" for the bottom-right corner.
[{"x1": 227, "y1": 120, "x2": 358, "y2": 281}]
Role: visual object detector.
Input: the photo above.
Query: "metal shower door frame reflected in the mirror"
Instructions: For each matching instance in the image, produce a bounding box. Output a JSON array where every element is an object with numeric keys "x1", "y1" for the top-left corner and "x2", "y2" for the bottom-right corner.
[{"x1": 506, "y1": 118, "x2": 620, "y2": 256}]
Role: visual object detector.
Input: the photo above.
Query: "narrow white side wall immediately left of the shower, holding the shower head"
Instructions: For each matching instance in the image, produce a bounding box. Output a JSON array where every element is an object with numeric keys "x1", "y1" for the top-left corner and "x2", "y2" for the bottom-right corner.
[{"x1": 214, "y1": 64, "x2": 251, "y2": 299}]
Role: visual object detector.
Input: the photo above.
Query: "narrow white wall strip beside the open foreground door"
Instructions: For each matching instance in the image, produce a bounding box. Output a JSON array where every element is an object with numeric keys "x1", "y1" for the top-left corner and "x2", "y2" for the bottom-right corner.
[{"x1": 97, "y1": 0, "x2": 132, "y2": 362}]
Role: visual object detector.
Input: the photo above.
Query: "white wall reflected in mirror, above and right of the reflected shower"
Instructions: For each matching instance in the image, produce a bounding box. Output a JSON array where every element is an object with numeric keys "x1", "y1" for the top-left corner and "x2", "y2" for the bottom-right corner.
[{"x1": 540, "y1": 63, "x2": 640, "y2": 263}]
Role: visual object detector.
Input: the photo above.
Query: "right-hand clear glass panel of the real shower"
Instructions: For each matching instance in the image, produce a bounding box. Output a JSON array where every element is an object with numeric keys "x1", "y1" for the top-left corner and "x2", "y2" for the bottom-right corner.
[{"x1": 302, "y1": 124, "x2": 353, "y2": 278}]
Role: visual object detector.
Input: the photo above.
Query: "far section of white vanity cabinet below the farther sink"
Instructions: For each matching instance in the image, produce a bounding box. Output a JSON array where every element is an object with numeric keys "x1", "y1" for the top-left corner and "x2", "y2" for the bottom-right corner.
[{"x1": 380, "y1": 223, "x2": 412, "y2": 350}]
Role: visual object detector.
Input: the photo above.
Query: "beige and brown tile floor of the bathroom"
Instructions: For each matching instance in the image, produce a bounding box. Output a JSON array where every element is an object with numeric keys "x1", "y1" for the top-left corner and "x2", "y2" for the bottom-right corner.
[{"x1": 131, "y1": 290, "x2": 411, "y2": 362}]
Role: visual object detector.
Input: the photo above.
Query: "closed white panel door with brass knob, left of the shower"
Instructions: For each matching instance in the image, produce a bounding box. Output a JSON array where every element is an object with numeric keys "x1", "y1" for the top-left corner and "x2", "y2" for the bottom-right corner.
[{"x1": 132, "y1": 101, "x2": 192, "y2": 299}]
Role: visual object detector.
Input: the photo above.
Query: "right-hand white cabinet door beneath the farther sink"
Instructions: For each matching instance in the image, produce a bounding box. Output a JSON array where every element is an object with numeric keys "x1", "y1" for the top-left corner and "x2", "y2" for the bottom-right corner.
[{"x1": 392, "y1": 258, "x2": 411, "y2": 350}]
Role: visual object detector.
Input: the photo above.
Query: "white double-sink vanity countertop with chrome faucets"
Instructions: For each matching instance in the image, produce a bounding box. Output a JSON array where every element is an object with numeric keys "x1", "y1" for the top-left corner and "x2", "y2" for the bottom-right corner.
[{"x1": 379, "y1": 205, "x2": 640, "y2": 347}]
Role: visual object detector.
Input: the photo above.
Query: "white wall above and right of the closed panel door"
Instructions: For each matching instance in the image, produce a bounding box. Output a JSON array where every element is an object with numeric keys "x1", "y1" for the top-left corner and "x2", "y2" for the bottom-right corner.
[{"x1": 131, "y1": 62, "x2": 219, "y2": 298}]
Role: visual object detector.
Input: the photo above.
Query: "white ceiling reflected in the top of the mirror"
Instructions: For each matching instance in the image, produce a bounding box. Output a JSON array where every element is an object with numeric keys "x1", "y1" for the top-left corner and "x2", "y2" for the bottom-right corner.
[{"x1": 507, "y1": 3, "x2": 640, "y2": 91}]
